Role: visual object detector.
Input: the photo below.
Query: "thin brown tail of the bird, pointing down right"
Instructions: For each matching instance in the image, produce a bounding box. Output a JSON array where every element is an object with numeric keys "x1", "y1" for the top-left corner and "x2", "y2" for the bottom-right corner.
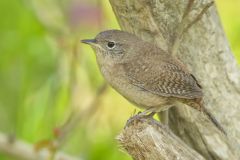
[{"x1": 188, "y1": 99, "x2": 227, "y2": 135}]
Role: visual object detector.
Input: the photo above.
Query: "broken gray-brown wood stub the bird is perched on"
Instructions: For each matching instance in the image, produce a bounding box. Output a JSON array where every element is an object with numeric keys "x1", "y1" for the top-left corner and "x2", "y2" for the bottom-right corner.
[{"x1": 117, "y1": 116, "x2": 204, "y2": 160}]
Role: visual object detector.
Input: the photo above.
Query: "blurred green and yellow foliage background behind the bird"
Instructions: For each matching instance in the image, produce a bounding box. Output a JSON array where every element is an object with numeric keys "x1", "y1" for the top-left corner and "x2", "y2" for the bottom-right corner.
[{"x1": 0, "y1": 0, "x2": 240, "y2": 160}]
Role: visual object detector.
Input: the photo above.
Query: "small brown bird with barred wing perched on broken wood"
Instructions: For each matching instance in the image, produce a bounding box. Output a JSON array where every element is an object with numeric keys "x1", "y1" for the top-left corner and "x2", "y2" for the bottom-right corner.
[{"x1": 82, "y1": 30, "x2": 225, "y2": 133}]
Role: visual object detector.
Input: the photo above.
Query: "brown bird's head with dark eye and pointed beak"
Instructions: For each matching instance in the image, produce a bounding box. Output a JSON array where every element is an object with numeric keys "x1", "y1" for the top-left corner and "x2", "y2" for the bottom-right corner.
[{"x1": 81, "y1": 30, "x2": 140, "y2": 63}]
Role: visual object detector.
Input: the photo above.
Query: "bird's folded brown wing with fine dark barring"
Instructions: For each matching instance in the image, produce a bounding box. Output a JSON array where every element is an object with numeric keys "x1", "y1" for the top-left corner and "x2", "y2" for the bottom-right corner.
[{"x1": 124, "y1": 55, "x2": 202, "y2": 99}]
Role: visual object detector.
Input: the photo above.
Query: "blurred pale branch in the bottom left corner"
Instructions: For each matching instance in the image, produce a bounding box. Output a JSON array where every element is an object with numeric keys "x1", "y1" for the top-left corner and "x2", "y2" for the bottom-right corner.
[{"x1": 0, "y1": 133, "x2": 80, "y2": 160}]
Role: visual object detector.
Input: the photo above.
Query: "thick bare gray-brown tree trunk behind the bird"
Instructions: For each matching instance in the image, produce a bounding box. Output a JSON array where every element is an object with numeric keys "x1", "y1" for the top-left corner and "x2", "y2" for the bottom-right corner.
[{"x1": 110, "y1": 0, "x2": 240, "y2": 160}]
